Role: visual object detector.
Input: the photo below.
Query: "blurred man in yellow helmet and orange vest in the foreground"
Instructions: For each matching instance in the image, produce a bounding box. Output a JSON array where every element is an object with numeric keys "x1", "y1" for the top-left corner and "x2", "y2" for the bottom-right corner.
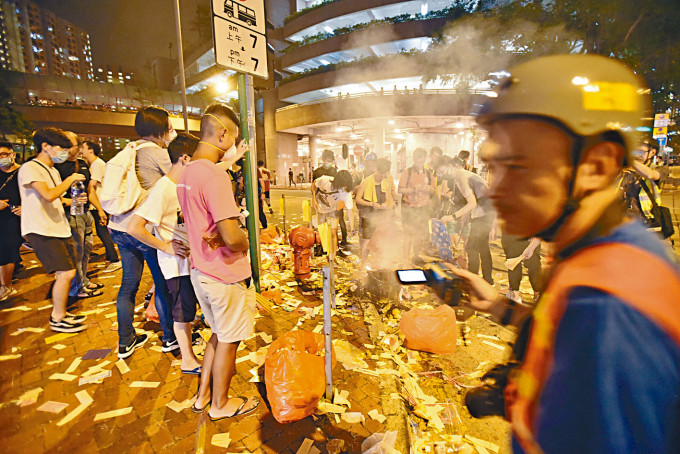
[{"x1": 446, "y1": 55, "x2": 680, "y2": 453}]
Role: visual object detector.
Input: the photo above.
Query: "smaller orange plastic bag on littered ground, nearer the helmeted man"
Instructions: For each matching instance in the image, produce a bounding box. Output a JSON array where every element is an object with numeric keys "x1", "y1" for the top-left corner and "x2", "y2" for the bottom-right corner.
[{"x1": 399, "y1": 305, "x2": 458, "y2": 354}]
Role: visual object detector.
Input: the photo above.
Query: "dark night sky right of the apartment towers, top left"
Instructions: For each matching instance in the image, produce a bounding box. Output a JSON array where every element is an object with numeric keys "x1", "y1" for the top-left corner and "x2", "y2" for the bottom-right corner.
[{"x1": 33, "y1": 0, "x2": 208, "y2": 82}]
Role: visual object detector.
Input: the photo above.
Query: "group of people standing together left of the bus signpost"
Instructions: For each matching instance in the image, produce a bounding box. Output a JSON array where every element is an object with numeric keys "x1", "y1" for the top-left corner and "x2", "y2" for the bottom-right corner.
[{"x1": 0, "y1": 104, "x2": 260, "y2": 420}]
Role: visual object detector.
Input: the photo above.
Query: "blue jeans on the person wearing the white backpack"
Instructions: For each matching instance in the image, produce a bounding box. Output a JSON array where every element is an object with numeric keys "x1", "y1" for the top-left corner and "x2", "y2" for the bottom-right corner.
[{"x1": 111, "y1": 230, "x2": 175, "y2": 346}]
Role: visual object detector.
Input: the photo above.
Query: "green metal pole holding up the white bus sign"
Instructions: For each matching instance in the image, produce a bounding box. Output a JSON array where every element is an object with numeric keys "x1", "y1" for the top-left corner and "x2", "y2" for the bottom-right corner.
[{"x1": 238, "y1": 73, "x2": 260, "y2": 292}]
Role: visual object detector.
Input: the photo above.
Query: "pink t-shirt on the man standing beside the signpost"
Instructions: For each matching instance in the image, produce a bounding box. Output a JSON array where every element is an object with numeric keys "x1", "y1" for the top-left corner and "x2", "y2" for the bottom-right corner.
[{"x1": 177, "y1": 159, "x2": 251, "y2": 284}]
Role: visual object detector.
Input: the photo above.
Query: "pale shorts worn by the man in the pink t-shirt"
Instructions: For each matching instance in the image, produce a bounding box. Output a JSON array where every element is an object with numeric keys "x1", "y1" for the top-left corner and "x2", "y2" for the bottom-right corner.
[{"x1": 191, "y1": 268, "x2": 257, "y2": 343}]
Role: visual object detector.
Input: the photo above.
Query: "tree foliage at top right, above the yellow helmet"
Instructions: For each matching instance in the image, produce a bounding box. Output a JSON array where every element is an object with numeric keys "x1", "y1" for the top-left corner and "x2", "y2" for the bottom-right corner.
[{"x1": 427, "y1": 0, "x2": 680, "y2": 122}]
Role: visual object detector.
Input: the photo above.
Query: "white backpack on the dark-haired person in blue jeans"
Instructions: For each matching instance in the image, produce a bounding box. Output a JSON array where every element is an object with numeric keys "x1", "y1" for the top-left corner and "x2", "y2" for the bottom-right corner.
[{"x1": 99, "y1": 142, "x2": 144, "y2": 216}]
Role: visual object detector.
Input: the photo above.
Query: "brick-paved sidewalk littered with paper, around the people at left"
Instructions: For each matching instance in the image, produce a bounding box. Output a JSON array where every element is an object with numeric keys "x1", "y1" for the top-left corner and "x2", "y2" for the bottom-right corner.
[{"x1": 0, "y1": 243, "x2": 384, "y2": 454}]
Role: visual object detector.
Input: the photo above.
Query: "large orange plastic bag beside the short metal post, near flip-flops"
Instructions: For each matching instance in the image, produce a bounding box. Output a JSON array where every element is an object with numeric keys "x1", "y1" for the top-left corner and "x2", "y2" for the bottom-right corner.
[{"x1": 264, "y1": 331, "x2": 335, "y2": 423}]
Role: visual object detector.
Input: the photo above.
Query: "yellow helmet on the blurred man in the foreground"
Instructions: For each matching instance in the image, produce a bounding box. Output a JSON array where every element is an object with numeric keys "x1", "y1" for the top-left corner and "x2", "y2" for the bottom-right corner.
[{"x1": 478, "y1": 55, "x2": 651, "y2": 162}]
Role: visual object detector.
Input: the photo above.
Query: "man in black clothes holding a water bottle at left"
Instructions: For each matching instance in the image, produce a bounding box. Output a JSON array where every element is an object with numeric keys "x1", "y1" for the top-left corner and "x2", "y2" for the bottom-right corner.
[{"x1": 54, "y1": 131, "x2": 104, "y2": 298}]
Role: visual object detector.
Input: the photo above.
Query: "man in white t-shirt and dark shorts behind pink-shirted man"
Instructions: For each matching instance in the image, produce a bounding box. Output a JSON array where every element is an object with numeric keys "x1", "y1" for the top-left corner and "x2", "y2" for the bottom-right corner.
[{"x1": 127, "y1": 132, "x2": 201, "y2": 375}]
